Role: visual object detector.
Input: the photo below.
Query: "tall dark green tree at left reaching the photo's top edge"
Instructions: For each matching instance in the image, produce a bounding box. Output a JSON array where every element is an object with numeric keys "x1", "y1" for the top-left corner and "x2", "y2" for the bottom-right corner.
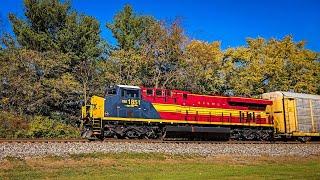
[{"x1": 9, "y1": 0, "x2": 104, "y2": 105}]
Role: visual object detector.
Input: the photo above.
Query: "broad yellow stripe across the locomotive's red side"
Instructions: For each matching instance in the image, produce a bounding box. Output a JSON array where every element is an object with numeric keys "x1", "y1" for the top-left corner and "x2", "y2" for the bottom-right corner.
[{"x1": 152, "y1": 103, "x2": 267, "y2": 118}]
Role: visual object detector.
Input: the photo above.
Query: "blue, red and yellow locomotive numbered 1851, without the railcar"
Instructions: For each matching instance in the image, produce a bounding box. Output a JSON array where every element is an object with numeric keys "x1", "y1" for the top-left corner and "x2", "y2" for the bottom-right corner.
[{"x1": 82, "y1": 85, "x2": 273, "y2": 140}]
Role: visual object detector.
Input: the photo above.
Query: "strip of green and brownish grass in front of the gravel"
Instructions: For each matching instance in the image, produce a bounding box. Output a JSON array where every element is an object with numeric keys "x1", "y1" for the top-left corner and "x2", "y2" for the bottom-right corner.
[{"x1": 0, "y1": 153, "x2": 320, "y2": 180}]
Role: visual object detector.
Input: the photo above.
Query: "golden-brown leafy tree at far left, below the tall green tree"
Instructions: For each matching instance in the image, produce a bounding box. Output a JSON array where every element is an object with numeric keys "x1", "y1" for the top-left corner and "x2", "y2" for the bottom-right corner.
[{"x1": 0, "y1": 49, "x2": 81, "y2": 122}]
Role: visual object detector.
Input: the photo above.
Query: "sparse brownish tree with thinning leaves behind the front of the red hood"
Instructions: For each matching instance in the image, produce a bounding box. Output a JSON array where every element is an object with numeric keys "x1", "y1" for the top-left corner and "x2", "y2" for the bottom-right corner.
[{"x1": 140, "y1": 20, "x2": 187, "y2": 88}]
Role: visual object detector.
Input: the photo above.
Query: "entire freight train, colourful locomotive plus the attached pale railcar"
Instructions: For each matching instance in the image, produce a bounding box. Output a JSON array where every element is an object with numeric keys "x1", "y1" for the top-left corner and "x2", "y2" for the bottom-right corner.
[{"x1": 81, "y1": 85, "x2": 320, "y2": 141}]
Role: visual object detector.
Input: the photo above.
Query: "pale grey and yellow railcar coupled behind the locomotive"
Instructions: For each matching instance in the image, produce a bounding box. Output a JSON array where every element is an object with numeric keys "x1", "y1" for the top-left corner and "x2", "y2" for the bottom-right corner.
[{"x1": 262, "y1": 91, "x2": 320, "y2": 136}]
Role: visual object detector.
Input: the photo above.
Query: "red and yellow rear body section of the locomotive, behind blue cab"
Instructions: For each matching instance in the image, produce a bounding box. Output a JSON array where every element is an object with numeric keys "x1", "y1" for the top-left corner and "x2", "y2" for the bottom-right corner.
[{"x1": 142, "y1": 88, "x2": 273, "y2": 126}]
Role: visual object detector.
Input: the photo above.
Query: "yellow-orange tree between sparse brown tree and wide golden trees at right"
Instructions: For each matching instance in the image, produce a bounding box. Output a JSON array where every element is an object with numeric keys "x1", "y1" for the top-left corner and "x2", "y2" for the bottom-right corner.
[{"x1": 182, "y1": 40, "x2": 225, "y2": 94}]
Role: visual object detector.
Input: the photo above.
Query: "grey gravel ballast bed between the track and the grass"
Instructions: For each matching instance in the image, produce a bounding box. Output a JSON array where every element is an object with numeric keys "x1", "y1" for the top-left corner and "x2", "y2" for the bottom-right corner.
[{"x1": 0, "y1": 142, "x2": 320, "y2": 159}]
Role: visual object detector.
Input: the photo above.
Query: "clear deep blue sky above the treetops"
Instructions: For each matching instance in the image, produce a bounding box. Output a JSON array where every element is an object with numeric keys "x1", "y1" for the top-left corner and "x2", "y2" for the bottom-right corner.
[{"x1": 0, "y1": 0, "x2": 320, "y2": 52}]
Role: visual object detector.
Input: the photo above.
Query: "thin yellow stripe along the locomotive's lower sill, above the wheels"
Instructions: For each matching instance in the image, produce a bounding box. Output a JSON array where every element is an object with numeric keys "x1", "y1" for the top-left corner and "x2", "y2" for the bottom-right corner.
[{"x1": 102, "y1": 117, "x2": 273, "y2": 127}]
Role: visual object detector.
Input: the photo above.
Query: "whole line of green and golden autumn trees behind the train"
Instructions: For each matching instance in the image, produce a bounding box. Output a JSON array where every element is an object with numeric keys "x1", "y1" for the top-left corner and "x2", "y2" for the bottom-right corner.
[{"x1": 0, "y1": 0, "x2": 320, "y2": 137}]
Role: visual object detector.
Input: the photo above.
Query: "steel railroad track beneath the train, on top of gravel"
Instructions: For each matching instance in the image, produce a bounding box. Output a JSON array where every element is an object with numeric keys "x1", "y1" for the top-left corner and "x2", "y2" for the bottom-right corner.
[{"x1": 0, "y1": 139, "x2": 320, "y2": 144}]
